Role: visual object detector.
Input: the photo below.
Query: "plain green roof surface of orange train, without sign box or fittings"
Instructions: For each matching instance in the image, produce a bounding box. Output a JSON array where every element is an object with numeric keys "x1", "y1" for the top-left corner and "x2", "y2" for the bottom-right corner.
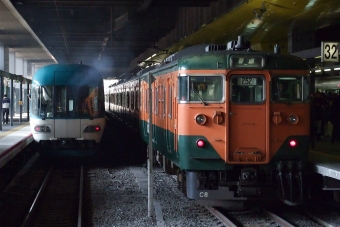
[{"x1": 137, "y1": 44, "x2": 310, "y2": 77}]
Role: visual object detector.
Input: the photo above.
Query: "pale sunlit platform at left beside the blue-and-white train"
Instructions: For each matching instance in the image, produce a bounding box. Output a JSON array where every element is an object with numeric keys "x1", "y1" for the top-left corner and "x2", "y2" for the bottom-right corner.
[{"x1": 0, "y1": 115, "x2": 33, "y2": 168}]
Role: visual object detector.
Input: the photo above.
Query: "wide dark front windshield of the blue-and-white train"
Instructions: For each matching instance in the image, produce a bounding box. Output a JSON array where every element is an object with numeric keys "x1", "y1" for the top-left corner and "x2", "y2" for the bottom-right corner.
[{"x1": 31, "y1": 84, "x2": 104, "y2": 118}]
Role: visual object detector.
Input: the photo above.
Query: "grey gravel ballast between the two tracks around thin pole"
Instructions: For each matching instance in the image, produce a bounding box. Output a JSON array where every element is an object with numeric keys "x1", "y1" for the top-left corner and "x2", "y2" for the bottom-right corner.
[{"x1": 85, "y1": 167, "x2": 224, "y2": 227}]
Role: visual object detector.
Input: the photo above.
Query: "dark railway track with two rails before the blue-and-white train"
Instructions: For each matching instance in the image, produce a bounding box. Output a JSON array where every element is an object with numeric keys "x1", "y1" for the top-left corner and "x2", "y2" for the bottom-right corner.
[{"x1": 21, "y1": 167, "x2": 83, "y2": 227}]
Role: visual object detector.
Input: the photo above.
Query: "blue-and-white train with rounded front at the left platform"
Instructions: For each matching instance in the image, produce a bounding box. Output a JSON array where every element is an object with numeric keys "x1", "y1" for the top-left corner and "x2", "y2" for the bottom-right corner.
[{"x1": 30, "y1": 64, "x2": 105, "y2": 156}]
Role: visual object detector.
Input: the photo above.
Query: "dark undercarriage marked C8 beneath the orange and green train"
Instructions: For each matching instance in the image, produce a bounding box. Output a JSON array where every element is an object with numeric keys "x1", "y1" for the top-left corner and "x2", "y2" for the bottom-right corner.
[{"x1": 162, "y1": 154, "x2": 307, "y2": 207}]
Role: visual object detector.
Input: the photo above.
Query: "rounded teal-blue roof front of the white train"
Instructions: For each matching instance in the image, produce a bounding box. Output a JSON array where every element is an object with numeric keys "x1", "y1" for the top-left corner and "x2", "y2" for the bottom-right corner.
[{"x1": 32, "y1": 64, "x2": 103, "y2": 86}]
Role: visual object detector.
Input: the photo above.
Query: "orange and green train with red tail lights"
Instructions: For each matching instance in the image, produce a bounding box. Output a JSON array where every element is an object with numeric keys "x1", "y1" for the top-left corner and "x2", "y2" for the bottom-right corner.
[{"x1": 105, "y1": 37, "x2": 310, "y2": 205}]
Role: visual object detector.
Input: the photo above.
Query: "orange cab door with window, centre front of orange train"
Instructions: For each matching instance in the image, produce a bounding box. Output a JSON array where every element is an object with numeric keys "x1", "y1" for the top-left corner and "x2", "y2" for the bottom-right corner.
[{"x1": 226, "y1": 70, "x2": 269, "y2": 164}]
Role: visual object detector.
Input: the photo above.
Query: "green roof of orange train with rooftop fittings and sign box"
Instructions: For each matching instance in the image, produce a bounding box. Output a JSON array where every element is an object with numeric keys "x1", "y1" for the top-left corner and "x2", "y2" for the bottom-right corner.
[{"x1": 111, "y1": 36, "x2": 310, "y2": 86}]
